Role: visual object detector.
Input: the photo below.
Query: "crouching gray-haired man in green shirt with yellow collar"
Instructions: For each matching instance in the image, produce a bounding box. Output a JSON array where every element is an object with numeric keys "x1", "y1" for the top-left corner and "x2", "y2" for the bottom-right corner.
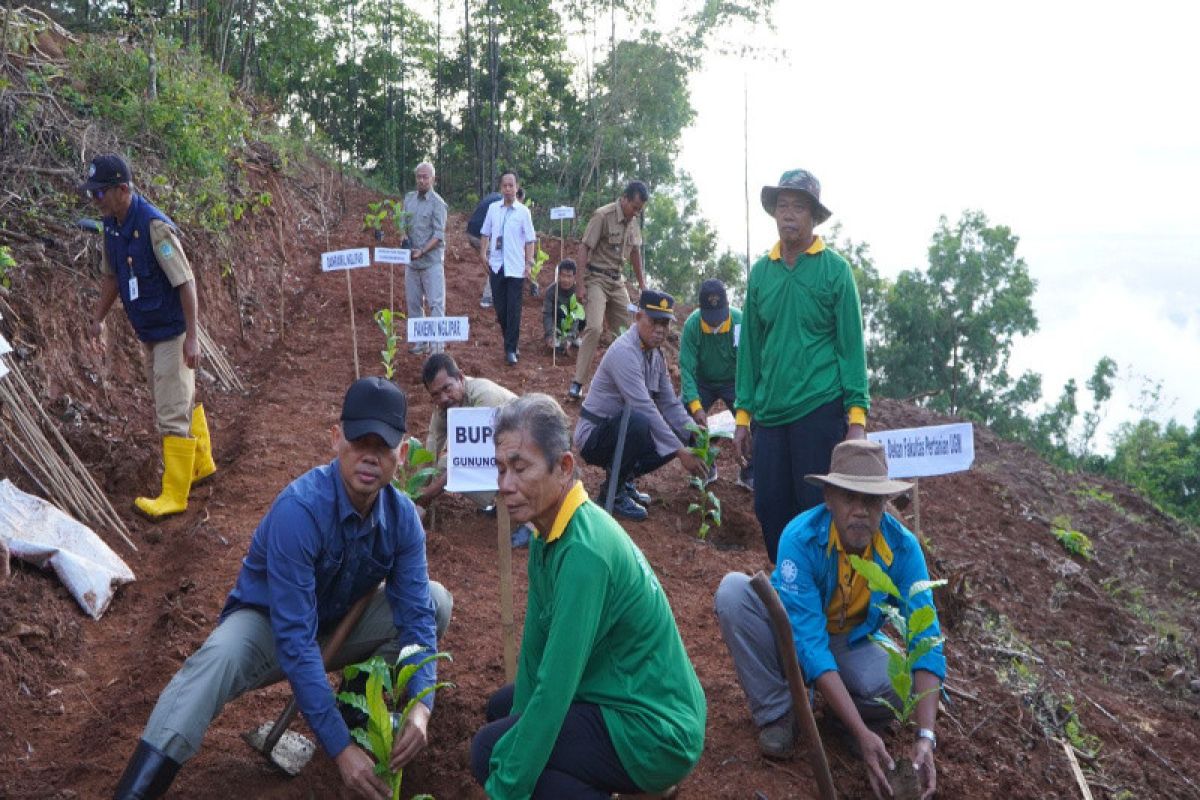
[{"x1": 470, "y1": 395, "x2": 706, "y2": 800}]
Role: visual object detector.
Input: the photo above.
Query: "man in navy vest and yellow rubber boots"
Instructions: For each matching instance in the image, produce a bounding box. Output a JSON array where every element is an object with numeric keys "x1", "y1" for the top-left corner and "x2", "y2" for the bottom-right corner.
[{"x1": 79, "y1": 155, "x2": 217, "y2": 521}]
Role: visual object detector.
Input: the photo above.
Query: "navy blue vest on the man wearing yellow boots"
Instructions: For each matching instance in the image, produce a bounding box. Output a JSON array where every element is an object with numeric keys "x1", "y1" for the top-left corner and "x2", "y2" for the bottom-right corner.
[{"x1": 104, "y1": 194, "x2": 187, "y2": 342}]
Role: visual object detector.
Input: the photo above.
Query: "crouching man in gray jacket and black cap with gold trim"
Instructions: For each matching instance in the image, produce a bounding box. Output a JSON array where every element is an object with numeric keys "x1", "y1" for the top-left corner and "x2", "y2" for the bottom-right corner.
[{"x1": 575, "y1": 289, "x2": 707, "y2": 519}]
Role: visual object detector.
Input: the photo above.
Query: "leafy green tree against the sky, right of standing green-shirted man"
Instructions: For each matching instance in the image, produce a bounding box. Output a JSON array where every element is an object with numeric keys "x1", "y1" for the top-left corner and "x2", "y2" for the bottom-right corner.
[{"x1": 871, "y1": 211, "x2": 1040, "y2": 432}]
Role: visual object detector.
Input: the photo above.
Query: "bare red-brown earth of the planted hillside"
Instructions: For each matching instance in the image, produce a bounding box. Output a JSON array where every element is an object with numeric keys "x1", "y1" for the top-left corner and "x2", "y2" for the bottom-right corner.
[{"x1": 0, "y1": 157, "x2": 1200, "y2": 800}]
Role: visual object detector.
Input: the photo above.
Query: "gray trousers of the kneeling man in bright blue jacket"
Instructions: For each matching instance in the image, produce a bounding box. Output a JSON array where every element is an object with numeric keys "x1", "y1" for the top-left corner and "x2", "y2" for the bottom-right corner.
[{"x1": 715, "y1": 572, "x2": 898, "y2": 728}]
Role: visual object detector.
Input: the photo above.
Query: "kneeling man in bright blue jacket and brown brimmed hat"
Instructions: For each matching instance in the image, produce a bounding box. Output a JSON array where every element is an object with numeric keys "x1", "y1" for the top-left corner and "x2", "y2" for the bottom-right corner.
[{"x1": 715, "y1": 439, "x2": 946, "y2": 798}]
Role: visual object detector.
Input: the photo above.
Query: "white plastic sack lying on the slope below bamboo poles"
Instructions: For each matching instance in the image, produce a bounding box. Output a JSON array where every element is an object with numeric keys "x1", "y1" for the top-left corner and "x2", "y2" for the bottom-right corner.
[{"x1": 0, "y1": 479, "x2": 134, "y2": 619}]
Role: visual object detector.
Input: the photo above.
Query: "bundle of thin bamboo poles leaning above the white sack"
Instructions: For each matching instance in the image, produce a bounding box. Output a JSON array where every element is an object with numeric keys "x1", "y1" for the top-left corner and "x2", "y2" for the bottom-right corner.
[{"x1": 0, "y1": 355, "x2": 138, "y2": 551}]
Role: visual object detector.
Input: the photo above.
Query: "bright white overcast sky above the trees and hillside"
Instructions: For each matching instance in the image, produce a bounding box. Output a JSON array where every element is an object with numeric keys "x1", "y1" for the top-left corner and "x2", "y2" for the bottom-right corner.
[{"x1": 680, "y1": 0, "x2": 1200, "y2": 448}]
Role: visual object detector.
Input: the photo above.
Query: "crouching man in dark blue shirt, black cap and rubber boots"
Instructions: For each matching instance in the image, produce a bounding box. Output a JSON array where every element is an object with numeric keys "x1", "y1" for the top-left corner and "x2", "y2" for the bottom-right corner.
[{"x1": 115, "y1": 378, "x2": 454, "y2": 800}]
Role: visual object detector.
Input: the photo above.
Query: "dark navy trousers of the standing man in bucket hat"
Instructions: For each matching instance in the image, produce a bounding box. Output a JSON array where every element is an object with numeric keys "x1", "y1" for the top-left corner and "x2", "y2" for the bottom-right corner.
[{"x1": 751, "y1": 399, "x2": 848, "y2": 564}]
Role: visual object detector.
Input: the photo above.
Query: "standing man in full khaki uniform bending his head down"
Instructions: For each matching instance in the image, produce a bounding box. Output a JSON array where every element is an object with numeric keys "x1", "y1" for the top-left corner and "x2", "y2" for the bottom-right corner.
[{"x1": 566, "y1": 181, "x2": 650, "y2": 401}]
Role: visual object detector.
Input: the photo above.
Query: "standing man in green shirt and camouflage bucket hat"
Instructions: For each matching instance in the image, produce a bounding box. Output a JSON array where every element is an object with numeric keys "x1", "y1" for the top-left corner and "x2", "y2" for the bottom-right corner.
[{"x1": 734, "y1": 169, "x2": 870, "y2": 564}]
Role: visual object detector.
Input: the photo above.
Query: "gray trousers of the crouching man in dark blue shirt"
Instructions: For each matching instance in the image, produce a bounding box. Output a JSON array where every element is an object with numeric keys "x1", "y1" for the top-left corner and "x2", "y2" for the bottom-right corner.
[{"x1": 142, "y1": 581, "x2": 454, "y2": 764}]
